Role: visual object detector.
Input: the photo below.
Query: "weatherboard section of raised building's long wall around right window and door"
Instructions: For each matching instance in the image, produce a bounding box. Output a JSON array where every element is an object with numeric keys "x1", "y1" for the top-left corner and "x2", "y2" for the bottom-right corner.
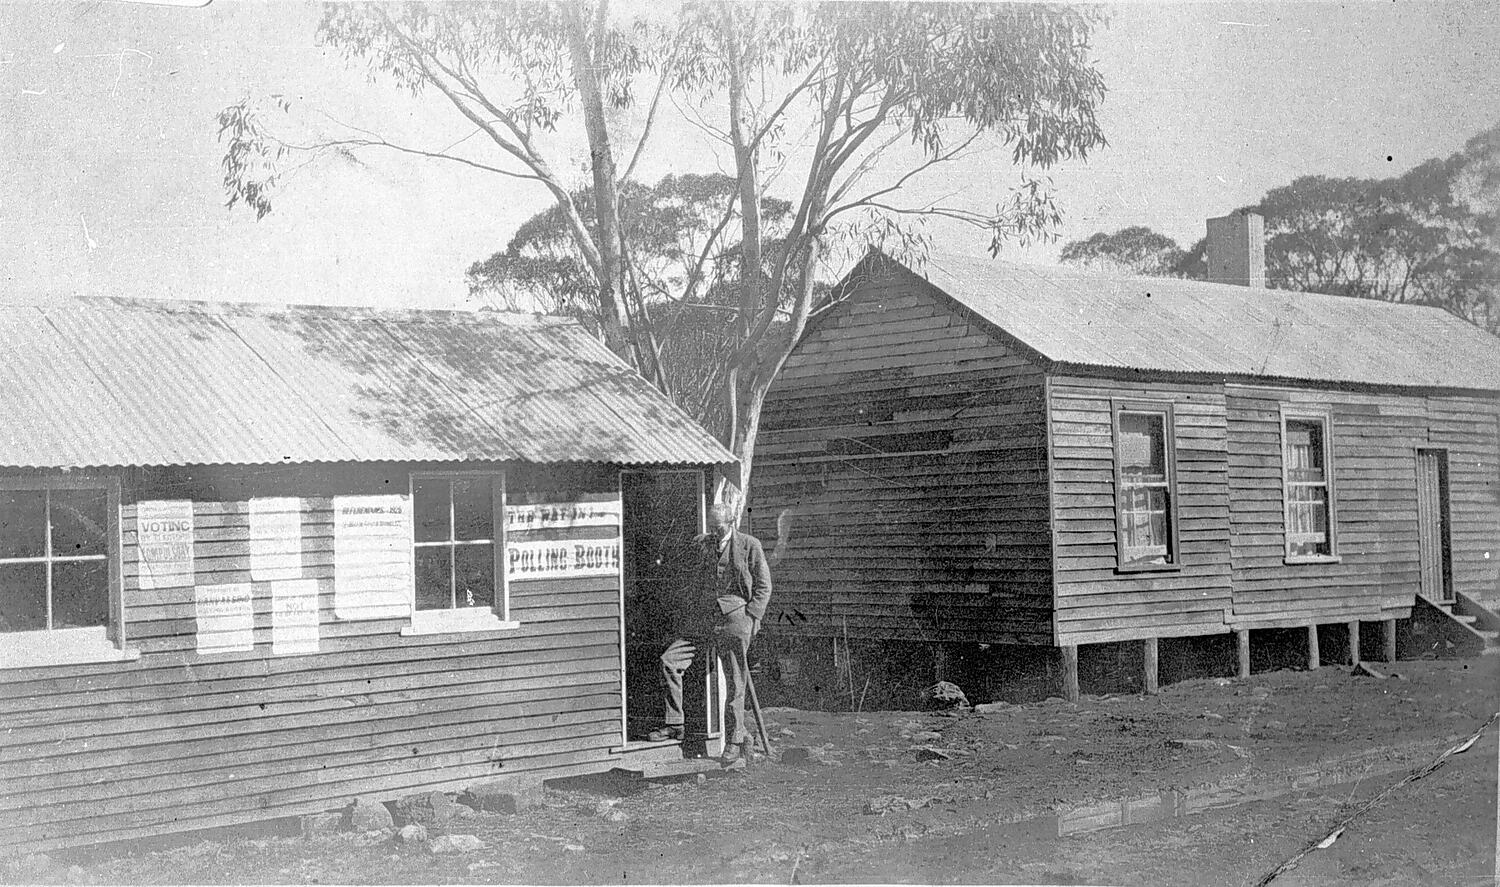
[{"x1": 1226, "y1": 384, "x2": 1500, "y2": 627}]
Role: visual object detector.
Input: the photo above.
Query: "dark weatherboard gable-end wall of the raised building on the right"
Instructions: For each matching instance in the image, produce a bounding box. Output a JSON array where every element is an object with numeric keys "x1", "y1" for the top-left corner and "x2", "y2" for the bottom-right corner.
[{"x1": 750, "y1": 272, "x2": 1052, "y2": 644}]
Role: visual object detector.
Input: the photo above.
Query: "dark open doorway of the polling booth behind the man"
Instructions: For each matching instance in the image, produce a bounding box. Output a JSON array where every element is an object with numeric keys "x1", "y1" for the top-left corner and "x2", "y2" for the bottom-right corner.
[{"x1": 620, "y1": 470, "x2": 720, "y2": 756}]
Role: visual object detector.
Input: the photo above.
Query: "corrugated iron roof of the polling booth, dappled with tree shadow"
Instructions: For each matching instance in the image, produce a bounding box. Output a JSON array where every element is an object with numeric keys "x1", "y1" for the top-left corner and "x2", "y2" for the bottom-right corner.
[{"x1": 0, "y1": 299, "x2": 734, "y2": 467}]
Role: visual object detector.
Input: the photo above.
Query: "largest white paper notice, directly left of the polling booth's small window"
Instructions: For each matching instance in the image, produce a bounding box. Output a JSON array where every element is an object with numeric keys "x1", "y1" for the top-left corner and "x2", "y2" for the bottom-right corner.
[{"x1": 333, "y1": 494, "x2": 413, "y2": 620}]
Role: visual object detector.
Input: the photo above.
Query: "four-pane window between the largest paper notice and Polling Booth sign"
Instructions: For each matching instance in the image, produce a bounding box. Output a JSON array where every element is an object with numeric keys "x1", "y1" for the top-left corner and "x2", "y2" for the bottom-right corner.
[{"x1": 407, "y1": 473, "x2": 515, "y2": 633}]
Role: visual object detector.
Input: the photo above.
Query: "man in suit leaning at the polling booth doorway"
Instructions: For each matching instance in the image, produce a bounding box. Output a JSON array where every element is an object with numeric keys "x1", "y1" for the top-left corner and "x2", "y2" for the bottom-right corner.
[{"x1": 651, "y1": 503, "x2": 771, "y2": 765}]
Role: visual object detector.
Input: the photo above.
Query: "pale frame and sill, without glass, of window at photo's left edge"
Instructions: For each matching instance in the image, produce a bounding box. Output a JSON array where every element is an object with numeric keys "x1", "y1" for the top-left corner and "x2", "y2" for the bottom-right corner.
[{"x1": 0, "y1": 473, "x2": 141, "y2": 669}]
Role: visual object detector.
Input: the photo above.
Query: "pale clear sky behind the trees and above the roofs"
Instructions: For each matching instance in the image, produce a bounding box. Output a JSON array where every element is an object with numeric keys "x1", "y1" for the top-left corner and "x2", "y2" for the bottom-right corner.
[{"x1": 0, "y1": 0, "x2": 1500, "y2": 306}]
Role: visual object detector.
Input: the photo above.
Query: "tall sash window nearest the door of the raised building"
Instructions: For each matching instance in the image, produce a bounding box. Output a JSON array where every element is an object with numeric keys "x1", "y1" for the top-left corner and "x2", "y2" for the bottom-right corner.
[{"x1": 1281, "y1": 416, "x2": 1337, "y2": 561}]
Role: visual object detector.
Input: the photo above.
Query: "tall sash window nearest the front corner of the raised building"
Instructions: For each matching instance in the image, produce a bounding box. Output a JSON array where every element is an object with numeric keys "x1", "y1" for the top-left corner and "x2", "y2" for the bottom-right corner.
[{"x1": 1115, "y1": 402, "x2": 1179, "y2": 570}]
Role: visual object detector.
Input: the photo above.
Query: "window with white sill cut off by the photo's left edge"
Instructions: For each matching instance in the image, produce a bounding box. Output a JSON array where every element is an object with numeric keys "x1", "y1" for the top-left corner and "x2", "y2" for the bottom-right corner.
[{"x1": 0, "y1": 477, "x2": 134, "y2": 668}]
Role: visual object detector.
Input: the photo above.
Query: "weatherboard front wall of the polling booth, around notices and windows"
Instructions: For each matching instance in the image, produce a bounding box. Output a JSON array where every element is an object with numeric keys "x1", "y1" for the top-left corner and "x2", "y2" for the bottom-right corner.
[{"x1": 0, "y1": 465, "x2": 633, "y2": 849}]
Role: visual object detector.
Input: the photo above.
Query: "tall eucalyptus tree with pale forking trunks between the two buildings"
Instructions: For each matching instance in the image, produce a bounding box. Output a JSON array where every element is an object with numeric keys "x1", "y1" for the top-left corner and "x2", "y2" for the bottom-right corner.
[{"x1": 221, "y1": 0, "x2": 1104, "y2": 501}]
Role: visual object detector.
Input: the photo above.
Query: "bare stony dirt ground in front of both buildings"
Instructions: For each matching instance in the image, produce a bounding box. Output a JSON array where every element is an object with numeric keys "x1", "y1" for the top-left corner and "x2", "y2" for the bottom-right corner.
[{"x1": 6, "y1": 656, "x2": 1500, "y2": 885}]
